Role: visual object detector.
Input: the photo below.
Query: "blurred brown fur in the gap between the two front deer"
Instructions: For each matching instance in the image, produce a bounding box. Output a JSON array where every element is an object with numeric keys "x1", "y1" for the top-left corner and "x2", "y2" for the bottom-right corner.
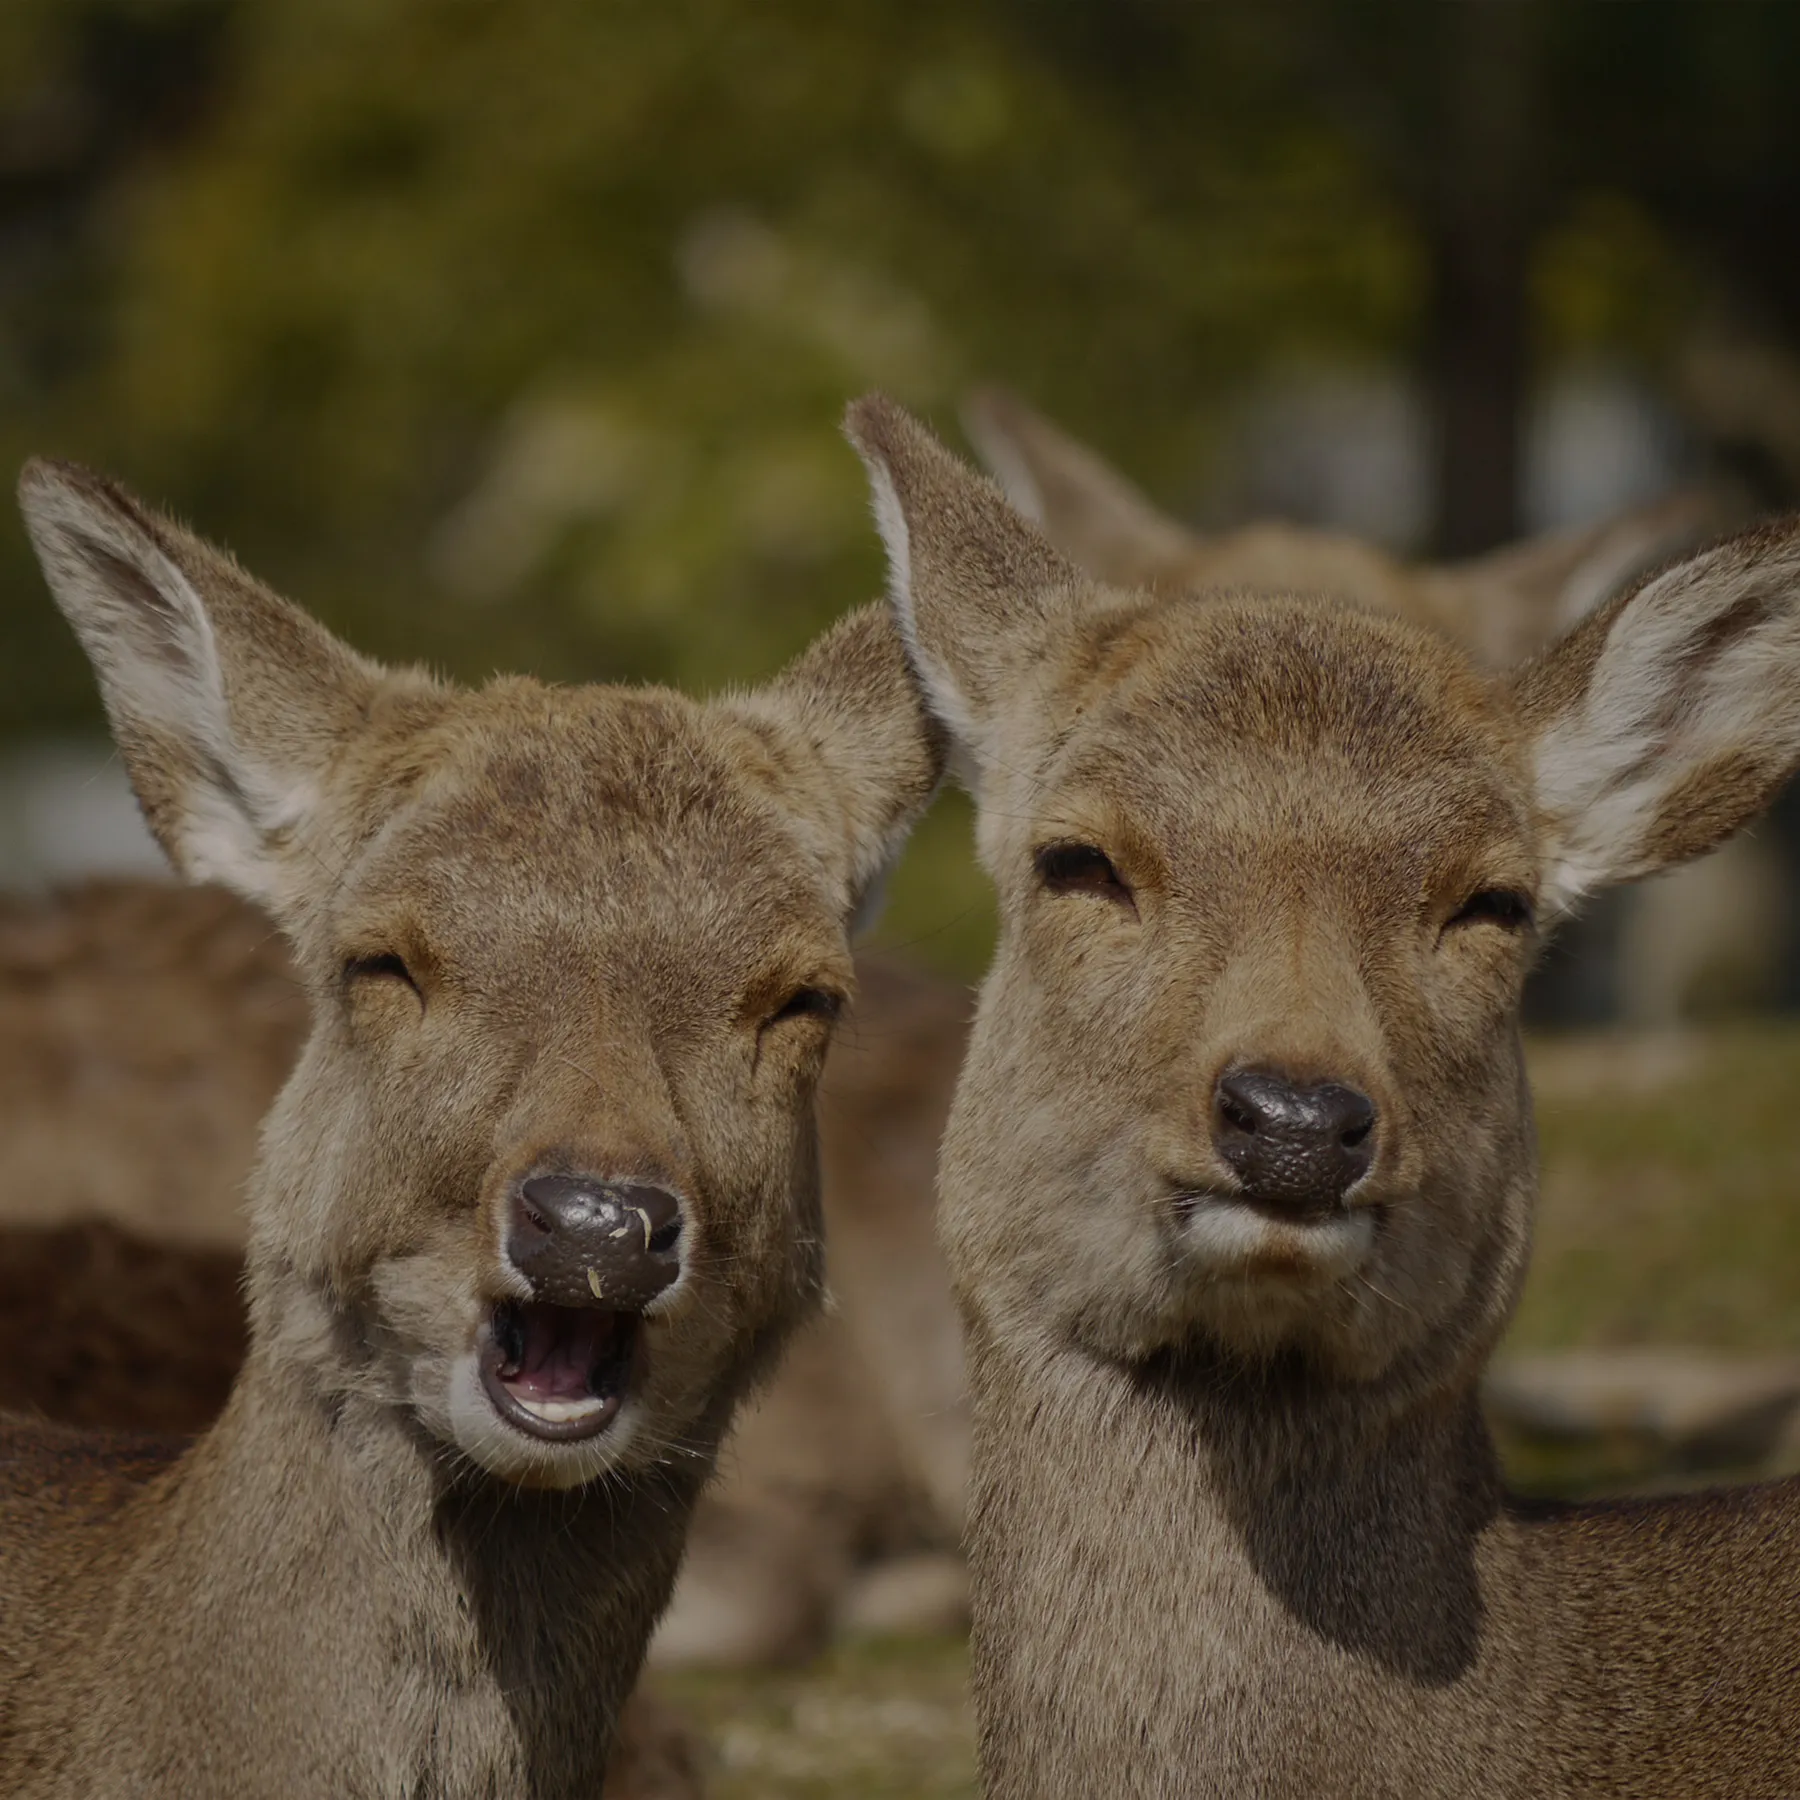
[{"x1": 652, "y1": 958, "x2": 968, "y2": 1665}]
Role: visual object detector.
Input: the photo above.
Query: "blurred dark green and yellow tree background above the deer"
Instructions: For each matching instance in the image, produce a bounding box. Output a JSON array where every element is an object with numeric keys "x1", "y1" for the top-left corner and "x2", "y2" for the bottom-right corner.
[{"x1": 10, "y1": 0, "x2": 1800, "y2": 1017}]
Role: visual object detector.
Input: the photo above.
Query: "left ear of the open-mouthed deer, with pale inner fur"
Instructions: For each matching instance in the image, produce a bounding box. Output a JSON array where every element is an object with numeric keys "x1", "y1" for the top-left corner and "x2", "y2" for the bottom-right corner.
[{"x1": 20, "y1": 463, "x2": 380, "y2": 913}]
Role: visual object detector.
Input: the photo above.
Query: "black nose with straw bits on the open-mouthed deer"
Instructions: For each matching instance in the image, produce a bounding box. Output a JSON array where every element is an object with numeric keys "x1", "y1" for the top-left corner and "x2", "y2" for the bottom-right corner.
[{"x1": 506, "y1": 1175, "x2": 680, "y2": 1312}]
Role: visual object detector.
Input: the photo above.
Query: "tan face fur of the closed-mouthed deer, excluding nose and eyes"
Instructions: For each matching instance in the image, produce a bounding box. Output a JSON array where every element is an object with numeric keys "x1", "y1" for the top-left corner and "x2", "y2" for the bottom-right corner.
[{"x1": 945, "y1": 583, "x2": 1534, "y2": 1373}]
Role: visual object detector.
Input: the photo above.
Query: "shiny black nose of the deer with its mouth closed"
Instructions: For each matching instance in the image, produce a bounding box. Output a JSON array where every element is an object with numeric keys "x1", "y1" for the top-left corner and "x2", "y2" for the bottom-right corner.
[{"x1": 1213, "y1": 1069, "x2": 1375, "y2": 1217}]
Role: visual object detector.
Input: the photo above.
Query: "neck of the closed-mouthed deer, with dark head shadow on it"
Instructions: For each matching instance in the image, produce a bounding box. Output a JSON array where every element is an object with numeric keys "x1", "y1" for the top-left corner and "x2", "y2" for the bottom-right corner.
[{"x1": 970, "y1": 1328, "x2": 1540, "y2": 1800}]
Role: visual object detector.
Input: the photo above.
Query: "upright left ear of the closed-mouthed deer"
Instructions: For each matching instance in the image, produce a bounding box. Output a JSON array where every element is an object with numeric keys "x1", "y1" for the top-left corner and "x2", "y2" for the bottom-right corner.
[{"x1": 844, "y1": 394, "x2": 1091, "y2": 785}]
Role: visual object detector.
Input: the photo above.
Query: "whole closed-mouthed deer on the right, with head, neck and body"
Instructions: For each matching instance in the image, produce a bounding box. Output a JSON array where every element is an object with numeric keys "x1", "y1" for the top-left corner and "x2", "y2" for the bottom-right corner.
[{"x1": 846, "y1": 396, "x2": 1800, "y2": 1800}]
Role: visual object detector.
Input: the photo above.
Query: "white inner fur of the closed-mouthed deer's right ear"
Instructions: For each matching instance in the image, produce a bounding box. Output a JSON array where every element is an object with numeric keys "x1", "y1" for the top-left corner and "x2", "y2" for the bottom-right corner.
[{"x1": 1535, "y1": 545, "x2": 1800, "y2": 916}]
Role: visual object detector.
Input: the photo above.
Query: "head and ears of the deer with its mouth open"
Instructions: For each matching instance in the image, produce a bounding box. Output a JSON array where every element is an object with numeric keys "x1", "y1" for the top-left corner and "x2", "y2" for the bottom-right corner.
[{"x1": 20, "y1": 463, "x2": 938, "y2": 1487}]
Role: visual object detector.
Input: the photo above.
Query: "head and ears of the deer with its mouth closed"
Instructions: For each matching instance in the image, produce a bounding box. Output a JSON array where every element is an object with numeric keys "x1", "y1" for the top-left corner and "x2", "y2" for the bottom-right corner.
[{"x1": 848, "y1": 398, "x2": 1800, "y2": 1391}]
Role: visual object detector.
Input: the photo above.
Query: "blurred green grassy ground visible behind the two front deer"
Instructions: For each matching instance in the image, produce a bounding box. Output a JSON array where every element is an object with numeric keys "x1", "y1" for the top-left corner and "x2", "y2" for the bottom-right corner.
[{"x1": 668, "y1": 1026, "x2": 1800, "y2": 1800}]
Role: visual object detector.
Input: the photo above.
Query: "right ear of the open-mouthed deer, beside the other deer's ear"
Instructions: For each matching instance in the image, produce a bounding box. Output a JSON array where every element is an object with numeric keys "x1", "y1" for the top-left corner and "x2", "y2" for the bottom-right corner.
[{"x1": 736, "y1": 607, "x2": 945, "y2": 923}]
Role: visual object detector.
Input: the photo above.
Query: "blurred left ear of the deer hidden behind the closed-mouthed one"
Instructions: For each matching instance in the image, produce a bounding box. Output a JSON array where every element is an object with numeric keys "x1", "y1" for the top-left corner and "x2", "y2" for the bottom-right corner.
[{"x1": 963, "y1": 387, "x2": 1199, "y2": 587}]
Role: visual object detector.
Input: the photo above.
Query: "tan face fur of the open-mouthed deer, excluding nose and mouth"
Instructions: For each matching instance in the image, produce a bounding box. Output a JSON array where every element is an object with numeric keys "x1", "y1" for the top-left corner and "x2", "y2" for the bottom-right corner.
[{"x1": 252, "y1": 682, "x2": 882, "y2": 1483}]
